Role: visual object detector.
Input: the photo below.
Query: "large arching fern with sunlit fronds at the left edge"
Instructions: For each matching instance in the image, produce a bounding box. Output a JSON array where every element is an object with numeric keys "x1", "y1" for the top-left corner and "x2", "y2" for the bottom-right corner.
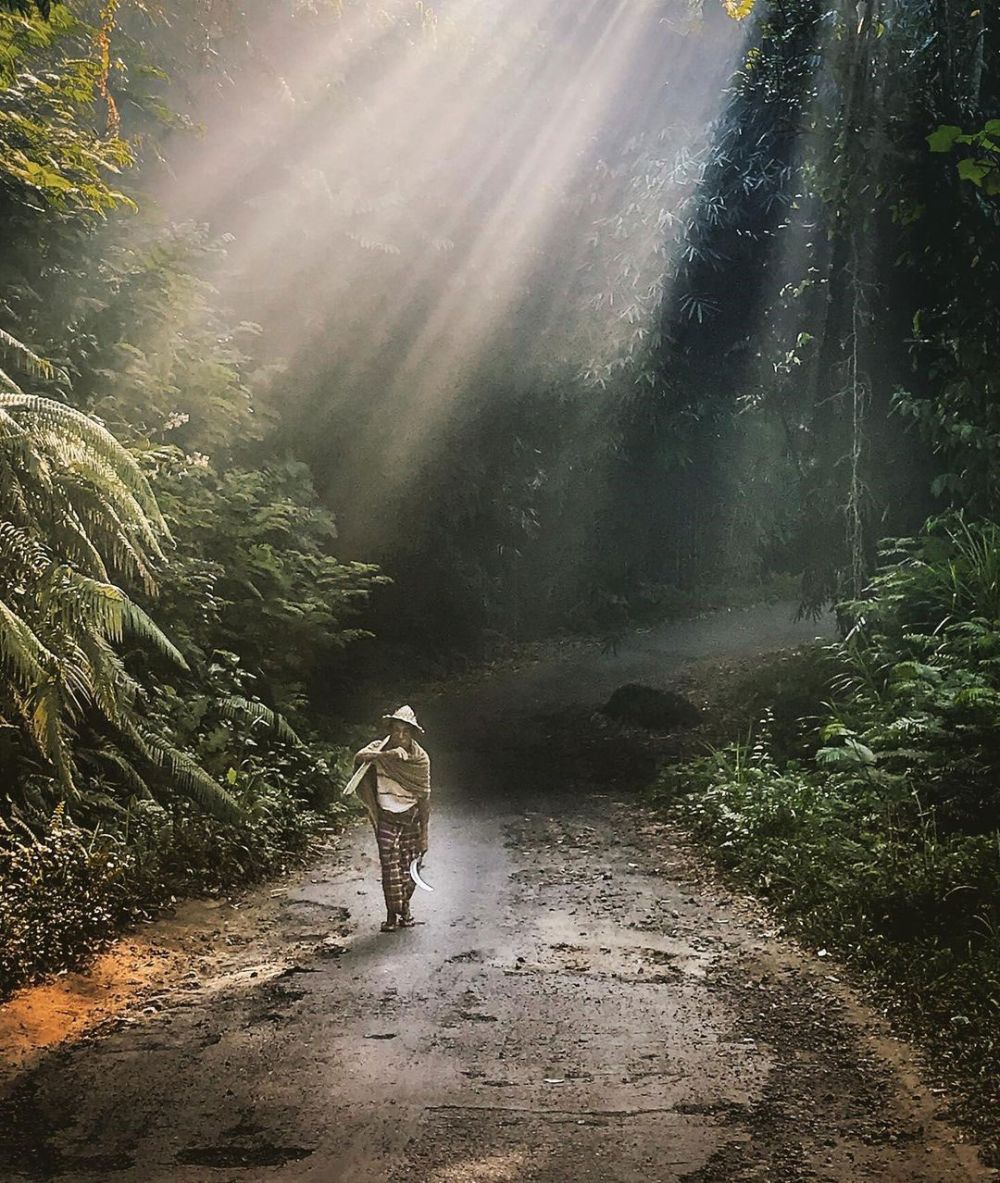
[{"x1": 0, "y1": 392, "x2": 238, "y2": 816}]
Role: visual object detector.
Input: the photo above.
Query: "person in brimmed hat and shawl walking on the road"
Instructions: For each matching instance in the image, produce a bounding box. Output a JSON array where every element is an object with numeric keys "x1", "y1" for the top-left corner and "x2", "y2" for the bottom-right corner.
[{"x1": 354, "y1": 706, "x2": 431, "y2": 932}]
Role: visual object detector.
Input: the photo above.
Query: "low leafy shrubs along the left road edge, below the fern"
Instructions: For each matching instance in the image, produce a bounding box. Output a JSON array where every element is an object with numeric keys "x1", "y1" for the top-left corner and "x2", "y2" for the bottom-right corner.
[{"x1": 0, "y1": 690, "x2": 371, "y2": 998}]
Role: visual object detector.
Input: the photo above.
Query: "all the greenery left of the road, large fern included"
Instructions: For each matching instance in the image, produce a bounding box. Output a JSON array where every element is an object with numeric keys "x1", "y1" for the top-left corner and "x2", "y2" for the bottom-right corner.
[{"x1": 0, "y1": 2, "x2": 380, "y2": 993}]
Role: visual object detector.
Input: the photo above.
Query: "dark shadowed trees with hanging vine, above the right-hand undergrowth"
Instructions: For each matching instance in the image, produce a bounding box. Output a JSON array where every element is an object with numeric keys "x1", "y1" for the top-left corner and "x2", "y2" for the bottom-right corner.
[{"x1": 664, "y1": 0, "x2": 1000, "y2": 606}]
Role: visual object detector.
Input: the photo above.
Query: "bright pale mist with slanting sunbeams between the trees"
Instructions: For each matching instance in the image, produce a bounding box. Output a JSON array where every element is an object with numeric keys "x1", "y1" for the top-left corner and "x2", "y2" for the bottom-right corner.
[{"x1": 150, "y1": 0, "x2": 744, "y2": 557}]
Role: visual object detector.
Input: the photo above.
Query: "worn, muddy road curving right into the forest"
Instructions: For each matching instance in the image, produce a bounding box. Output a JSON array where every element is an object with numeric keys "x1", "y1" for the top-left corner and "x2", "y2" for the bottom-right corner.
[{"x1": 0, "y1": 609, "x2": 994, "y2": 1183}]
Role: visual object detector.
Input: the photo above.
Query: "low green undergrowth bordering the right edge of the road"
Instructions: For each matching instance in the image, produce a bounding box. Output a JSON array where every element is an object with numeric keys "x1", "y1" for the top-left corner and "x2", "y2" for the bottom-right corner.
[{"x1": 656, "y1": 517, "x2": 1000, "y2": 1154}]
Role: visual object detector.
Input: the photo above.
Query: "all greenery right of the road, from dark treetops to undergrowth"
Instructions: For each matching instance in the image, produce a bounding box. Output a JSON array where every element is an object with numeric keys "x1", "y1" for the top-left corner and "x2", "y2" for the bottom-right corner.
[{"x1": 639, "y1": 0, "x2": 1000, "y2": 1135}]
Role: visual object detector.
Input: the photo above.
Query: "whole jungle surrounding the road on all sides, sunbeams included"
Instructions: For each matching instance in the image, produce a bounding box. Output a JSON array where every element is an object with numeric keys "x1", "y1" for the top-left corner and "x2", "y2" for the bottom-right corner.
[{"x1": 0, "y1": 0, "x2": 1000, "y2": 1183}]
